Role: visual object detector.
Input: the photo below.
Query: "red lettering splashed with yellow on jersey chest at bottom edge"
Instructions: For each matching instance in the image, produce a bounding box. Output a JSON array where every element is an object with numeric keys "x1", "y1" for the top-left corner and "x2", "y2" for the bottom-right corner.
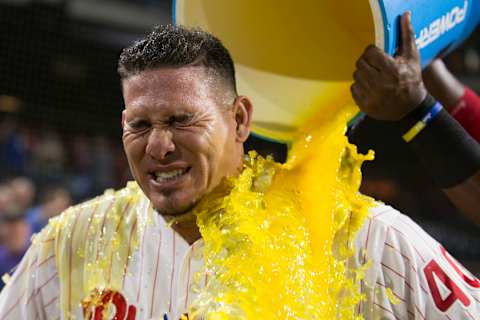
[{"x1": 82, "y1": 290, "x2": 137, "y2": 320}]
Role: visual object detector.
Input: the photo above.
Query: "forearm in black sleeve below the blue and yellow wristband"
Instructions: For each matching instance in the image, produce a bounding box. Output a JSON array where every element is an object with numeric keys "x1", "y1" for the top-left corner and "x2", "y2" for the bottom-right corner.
[{"x1": 396, "y1": 96, "x2": 480, "y2": 224}]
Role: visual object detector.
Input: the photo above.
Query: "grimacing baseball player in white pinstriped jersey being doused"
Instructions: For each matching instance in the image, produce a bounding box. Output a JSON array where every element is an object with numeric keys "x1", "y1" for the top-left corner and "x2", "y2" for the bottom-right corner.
[{"x1": 0, "y1": 13, "x2": 480, "y2": 320}]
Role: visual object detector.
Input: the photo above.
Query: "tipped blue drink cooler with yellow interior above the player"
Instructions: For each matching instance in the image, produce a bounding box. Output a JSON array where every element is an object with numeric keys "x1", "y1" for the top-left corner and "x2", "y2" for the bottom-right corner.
[{"x1": 173, "y1": 0, "x2": 480, "y2": 141}]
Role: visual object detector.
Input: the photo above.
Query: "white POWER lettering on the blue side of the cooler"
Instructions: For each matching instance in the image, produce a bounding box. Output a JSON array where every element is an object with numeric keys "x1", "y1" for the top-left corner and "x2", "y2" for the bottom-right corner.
[{"x1": 416, "y1": 0, "x2": 468, "y2": 49}]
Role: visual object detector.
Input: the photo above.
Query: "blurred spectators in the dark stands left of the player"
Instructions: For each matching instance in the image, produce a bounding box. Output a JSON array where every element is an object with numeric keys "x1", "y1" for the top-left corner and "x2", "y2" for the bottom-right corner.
[{"x1": 0, "y1": 116, "x2": 130, "y2": 288}]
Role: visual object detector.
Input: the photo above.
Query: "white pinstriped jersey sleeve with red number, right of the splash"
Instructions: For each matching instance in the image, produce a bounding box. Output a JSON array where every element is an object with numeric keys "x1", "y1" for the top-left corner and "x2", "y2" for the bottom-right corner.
[{"x1": 362, "y1": 209, "x2": 480, "y2": 320}]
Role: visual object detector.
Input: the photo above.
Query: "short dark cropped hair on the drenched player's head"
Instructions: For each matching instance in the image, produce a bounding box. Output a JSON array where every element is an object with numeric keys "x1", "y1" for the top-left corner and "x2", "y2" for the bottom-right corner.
[{"x1": 118, "y1": 24, "x2": 237, "y2": 95}]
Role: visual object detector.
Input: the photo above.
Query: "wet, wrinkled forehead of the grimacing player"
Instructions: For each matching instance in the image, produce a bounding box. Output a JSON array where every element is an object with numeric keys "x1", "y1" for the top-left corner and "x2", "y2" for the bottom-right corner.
[{"x1": 122, "y1": 66, "x2": 213, "y2": 108}]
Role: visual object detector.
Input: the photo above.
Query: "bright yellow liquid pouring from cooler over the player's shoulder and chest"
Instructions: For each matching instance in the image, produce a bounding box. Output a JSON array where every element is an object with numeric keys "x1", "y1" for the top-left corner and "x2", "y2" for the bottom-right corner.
[{"x1": 189, "y1": 104, "x2": 373, "y2": 320}]
